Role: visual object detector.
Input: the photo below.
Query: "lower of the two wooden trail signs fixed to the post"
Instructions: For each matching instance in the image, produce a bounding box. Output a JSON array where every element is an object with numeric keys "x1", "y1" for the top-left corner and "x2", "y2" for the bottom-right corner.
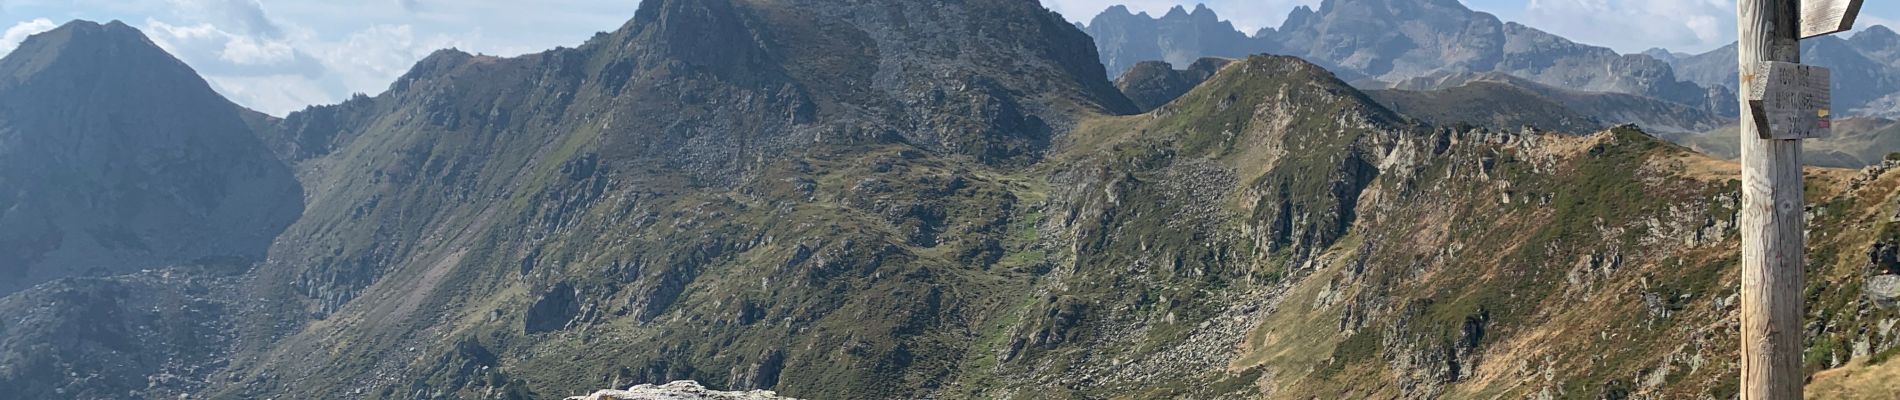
[{"x1": 1744, "y1": 61, "x2": 1834, "y2": 140}]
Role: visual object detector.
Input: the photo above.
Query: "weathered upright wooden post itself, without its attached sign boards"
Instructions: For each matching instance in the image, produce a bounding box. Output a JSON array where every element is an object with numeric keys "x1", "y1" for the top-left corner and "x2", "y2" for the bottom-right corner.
[{"x1": 1737, "y1": 0, "x2": 1807, "y2": 400}]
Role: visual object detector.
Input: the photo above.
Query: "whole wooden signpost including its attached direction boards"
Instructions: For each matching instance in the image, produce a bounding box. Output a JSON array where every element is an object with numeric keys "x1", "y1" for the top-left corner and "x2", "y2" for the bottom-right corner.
[{"x1": 1735, "y1": 0, "x2": 1860, "y2": 400}]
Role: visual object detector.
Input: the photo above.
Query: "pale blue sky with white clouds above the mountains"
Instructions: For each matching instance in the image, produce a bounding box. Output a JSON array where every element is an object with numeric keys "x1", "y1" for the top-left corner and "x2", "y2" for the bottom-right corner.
[{"x1": 0, "y1": 0, "x2": 1900, "y2": 116}]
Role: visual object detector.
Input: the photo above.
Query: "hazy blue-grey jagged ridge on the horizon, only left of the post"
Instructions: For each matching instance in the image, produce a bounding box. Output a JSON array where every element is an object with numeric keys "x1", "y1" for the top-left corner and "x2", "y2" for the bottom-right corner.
[{"x1": 1089, "y1": 0, "x2": 1727, "y2": 112}]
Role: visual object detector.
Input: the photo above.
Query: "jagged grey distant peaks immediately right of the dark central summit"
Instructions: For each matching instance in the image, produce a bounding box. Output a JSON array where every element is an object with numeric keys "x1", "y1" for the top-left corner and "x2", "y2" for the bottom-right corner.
[{"x1": 1085, "y1": 4, "x2": 1275, "y2": 76}]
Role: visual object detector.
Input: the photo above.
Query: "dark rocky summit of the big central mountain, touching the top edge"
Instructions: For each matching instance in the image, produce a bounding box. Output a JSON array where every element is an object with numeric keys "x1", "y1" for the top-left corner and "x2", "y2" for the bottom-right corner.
[{"x1": 591, "y1": 0, "x2": 1134, "y2": 161}]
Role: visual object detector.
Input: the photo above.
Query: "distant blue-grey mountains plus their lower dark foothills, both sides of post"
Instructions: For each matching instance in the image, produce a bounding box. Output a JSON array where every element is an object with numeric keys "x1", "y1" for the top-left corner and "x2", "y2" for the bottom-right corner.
[{"x1": 1083, "y1": 0, "x2": 1900, "y2": 167}]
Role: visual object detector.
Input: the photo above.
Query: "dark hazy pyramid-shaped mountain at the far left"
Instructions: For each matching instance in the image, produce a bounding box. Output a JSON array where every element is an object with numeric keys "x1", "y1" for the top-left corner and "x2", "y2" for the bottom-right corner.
[{"x1": 0, "y1": 23, "x2": 302, "y2": 294}]
